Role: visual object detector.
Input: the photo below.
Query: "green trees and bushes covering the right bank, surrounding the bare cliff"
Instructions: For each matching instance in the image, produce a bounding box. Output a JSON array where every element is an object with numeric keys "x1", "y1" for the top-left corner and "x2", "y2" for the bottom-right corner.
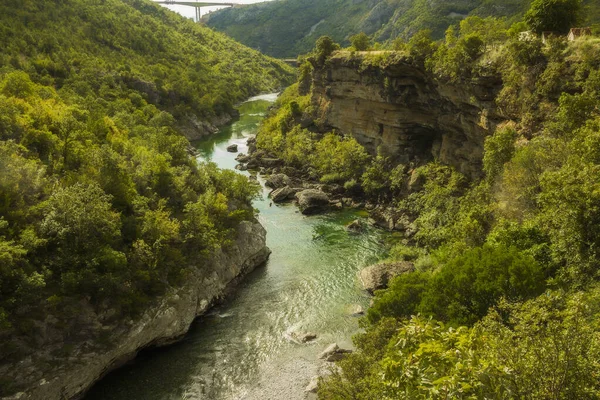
[{"x1": 257, "y1": 0, "x2": 600, "y2": 400}]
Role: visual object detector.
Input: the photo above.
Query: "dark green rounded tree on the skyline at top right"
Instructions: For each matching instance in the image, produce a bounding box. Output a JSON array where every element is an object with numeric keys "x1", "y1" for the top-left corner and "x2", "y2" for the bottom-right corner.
[{"x1": 525, "y1": 0, "x2": 582, "y2": 34}]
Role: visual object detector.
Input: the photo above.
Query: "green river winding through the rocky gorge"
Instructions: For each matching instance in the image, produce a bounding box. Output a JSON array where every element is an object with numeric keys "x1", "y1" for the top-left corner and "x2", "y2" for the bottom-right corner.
[{"x1": 86, "y1": 94, "x2": 388, "y2": 400}]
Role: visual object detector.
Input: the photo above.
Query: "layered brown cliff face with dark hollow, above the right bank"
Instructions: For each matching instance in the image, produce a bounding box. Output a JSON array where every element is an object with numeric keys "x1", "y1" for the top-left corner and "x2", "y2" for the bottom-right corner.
[{"x1": 312, "y1": 52, "x2": 505, "y2": 177}]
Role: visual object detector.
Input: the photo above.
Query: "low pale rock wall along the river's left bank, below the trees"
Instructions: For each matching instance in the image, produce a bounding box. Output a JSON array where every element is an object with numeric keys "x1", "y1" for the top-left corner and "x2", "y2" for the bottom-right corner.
[{"x1": 0, "y1": 222, "x2": 270, "y2": 400}]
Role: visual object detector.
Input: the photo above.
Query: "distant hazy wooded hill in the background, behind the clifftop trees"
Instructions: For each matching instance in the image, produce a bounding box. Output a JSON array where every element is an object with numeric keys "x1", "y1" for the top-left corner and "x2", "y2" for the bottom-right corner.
[{"x1": 206, "y1": 0, "x2": 600, "y2": 57}]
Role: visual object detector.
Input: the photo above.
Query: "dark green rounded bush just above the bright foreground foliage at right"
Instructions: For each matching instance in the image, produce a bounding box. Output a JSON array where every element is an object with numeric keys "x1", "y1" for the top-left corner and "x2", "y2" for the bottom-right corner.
[{"x1": 367, "y1": 245, "x2": 544, "y2": 325}]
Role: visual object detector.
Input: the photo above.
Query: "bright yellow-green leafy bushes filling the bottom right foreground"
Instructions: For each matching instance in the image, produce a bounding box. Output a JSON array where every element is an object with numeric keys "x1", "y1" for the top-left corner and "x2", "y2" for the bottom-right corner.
[{"x1": 319, "y1": 289, "x2": 600, "y2": 399}]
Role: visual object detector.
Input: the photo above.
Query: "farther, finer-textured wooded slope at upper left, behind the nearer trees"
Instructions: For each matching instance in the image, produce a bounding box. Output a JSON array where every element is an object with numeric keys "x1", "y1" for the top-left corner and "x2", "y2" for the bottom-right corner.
[{"x1": 0, "y1": 0, "x2": 291, "y2": 136}]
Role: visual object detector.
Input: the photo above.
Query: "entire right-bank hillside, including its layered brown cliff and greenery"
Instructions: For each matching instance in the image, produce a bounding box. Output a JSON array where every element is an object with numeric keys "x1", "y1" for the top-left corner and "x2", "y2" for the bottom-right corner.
[{"x1": 249, "y1": 17, "x2": 600, "y2": 400}]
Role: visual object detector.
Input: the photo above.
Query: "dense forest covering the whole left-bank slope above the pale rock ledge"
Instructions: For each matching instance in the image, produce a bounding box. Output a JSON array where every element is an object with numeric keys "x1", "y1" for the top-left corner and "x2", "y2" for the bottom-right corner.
[{"x1": 0, "y1": 0, "x2": 293, "y2": 385}]
